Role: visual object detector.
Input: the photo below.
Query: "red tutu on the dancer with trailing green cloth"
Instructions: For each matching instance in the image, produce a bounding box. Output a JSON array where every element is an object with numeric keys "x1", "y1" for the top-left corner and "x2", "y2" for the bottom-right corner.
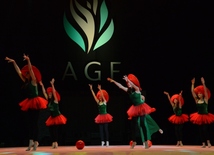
[{"x1": 127, "y1": 103, "x2": 156, "y2": 117}]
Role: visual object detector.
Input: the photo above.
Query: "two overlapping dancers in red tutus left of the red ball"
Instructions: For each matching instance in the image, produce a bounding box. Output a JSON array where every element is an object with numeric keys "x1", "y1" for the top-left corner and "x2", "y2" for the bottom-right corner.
[{"x1": 5, "y1": 54, "x2": 67, "y2": 151}]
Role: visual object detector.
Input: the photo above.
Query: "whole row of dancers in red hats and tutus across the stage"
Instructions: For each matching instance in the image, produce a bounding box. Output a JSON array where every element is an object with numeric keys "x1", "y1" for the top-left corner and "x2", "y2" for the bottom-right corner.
[{"x1": 5, "y1": 54, "x2": 214, "y2": 151}]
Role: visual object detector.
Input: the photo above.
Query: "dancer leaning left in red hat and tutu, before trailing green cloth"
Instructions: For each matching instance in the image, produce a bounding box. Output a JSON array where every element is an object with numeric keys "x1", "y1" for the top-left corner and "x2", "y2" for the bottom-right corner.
[{"x1": 107, "y1": 74, "x2": 160, "y2": 149}]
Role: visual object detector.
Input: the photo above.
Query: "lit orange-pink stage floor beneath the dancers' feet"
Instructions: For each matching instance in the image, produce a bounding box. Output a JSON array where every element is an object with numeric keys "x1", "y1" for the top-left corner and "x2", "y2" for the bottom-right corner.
[{"x1": 0, "y1": 145, "x2": 214, "y2": 155}]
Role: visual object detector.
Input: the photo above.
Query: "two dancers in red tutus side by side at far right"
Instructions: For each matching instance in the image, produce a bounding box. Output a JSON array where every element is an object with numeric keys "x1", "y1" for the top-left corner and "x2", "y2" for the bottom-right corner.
[{"x1": 164, "y1": 77, "x2": 214, "y2": 148}]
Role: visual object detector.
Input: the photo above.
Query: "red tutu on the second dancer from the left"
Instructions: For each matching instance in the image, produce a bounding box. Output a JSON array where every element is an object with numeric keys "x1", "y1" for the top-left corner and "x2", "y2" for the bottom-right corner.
[{"x1": 45, "y1": 114, "x2": 67, "y2": 126}]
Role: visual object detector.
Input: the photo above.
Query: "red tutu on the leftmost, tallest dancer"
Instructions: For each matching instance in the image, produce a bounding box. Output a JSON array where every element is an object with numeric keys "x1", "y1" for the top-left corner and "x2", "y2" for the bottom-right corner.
[{"x1": 19, "y1": 96, "x2": 48, "y2": 111}]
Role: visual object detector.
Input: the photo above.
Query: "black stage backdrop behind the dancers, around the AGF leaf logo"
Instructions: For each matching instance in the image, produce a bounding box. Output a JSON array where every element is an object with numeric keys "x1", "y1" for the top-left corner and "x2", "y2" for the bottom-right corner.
[{"x1": 0, "y1": 0, "x2": 214, "y2": 146}]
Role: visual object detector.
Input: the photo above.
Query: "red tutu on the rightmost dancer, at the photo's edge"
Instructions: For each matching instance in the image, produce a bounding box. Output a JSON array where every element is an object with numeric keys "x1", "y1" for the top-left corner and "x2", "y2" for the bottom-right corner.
[{"x1": 190, "y1": 112, "x2": 214, "y2": 125}]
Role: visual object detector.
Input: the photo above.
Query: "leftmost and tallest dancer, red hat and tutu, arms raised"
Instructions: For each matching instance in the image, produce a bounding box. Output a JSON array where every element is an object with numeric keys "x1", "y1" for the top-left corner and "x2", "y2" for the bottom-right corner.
[{"x1": 5, "y1": 54, "x2": 47, "y2": 151}]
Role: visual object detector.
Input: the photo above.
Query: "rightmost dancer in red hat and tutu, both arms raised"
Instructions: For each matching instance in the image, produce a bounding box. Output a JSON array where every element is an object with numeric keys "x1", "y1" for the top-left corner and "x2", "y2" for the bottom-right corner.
[{"x1": 190, "y1": 77, "x2": 214, "y2": 148}]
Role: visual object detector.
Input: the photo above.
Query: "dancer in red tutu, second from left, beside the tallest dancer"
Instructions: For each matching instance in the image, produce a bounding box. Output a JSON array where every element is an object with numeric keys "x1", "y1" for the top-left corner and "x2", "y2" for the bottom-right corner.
[{"x1": 39, "y1": 78, "x2": 67, "y2": 149}]
